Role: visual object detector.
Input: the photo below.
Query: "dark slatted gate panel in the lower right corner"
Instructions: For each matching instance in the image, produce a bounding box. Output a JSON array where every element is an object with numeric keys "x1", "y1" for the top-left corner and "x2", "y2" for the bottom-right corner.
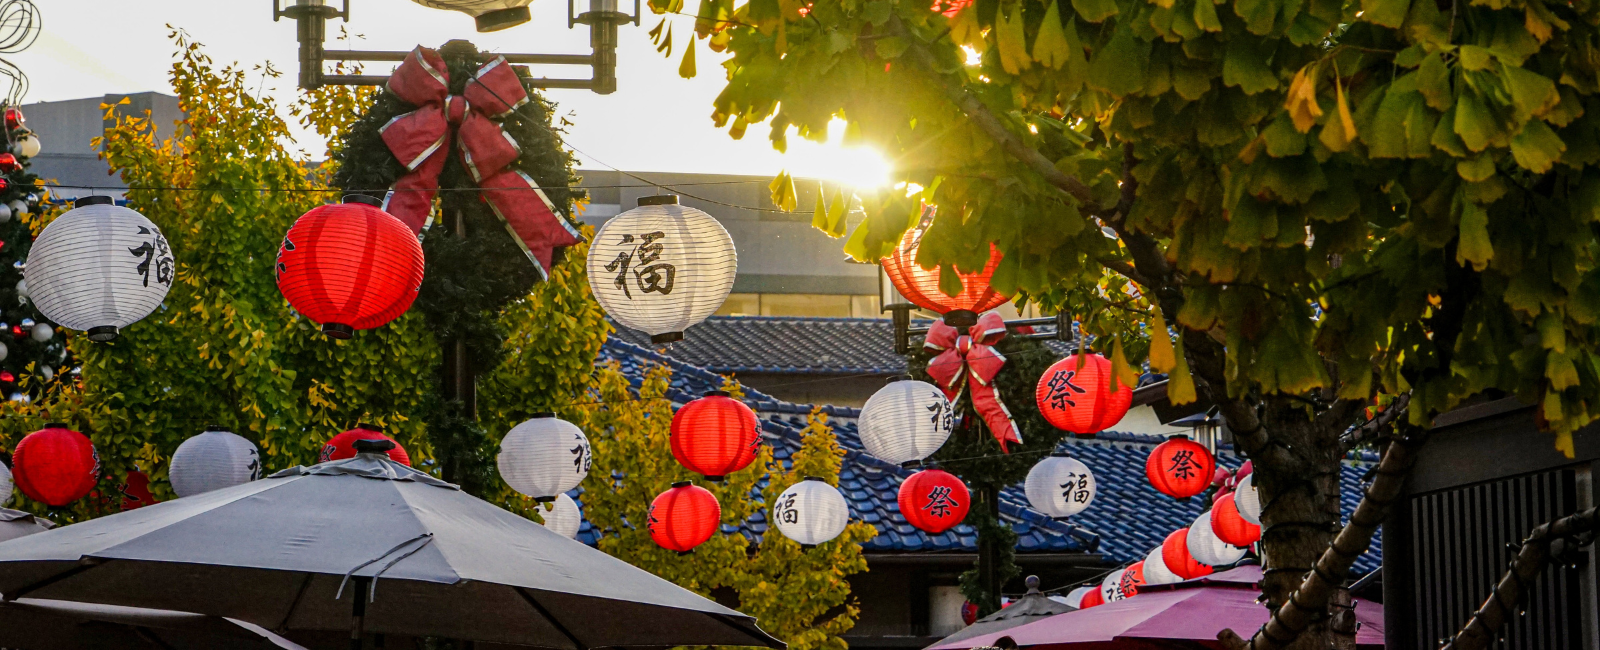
[{"x1": 1390, "y1": 469, "x2": 1584, "y2": 650}]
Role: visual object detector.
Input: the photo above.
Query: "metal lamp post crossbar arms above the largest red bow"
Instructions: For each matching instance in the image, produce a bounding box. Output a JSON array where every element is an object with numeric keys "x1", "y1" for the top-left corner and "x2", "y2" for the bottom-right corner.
[{"x1": 272, "y1": 0, "x2": 640, "y2": 94}]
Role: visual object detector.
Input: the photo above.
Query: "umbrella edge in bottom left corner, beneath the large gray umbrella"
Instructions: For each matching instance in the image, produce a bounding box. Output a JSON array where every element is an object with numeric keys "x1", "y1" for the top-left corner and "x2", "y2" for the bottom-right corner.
[{"x1": 0, "y1": 599, "x2": 306, "y2": 650}]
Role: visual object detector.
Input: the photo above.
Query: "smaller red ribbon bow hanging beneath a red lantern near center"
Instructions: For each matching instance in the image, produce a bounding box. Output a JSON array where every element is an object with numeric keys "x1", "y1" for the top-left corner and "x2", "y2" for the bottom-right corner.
[{"x1": 922, "y1": 312, "x2": 1022, "y2": 453}]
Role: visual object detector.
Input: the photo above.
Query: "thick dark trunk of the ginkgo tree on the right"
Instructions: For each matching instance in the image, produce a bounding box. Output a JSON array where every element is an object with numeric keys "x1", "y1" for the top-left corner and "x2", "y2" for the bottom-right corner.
[{"x1": 1254, "y1": 397, "x2": 1342, "y2": 650}]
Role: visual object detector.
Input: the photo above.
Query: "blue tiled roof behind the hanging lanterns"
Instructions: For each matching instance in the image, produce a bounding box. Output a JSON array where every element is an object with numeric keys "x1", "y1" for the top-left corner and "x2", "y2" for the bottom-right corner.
[{"x1": 579, "y1": 338, "x2": 1379, "y2": 573}]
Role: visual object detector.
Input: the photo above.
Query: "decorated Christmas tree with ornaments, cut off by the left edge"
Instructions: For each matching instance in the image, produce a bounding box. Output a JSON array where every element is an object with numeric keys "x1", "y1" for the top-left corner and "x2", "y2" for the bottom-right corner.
[{"x1": 0, "y1": 106, "x2": 75, "y2": 400}]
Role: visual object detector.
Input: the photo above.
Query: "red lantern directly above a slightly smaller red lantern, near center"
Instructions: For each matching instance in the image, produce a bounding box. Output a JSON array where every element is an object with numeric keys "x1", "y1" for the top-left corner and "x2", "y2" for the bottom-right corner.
[{"x1": 672, "y1": 391, "x2": 762, "y2": 480}]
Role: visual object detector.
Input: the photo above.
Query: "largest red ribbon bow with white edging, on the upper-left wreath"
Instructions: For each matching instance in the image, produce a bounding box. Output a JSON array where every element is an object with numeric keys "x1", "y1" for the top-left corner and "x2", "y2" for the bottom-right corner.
[{"x1": 379, "y1": 46, "x2": 582, "y2": 277}]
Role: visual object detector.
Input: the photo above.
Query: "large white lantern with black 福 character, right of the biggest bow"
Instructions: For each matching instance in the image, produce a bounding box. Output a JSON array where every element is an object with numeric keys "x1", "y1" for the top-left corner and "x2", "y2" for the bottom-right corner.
[{"x1": 589, "y1": 197, "x2": 739, "y2": 343}]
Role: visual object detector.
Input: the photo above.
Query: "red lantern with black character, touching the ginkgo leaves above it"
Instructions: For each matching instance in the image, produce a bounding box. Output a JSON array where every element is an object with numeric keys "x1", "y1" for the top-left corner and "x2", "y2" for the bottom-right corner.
[{"x1": 1034, "y1": 354, "x2": 1139, "y2": 438}]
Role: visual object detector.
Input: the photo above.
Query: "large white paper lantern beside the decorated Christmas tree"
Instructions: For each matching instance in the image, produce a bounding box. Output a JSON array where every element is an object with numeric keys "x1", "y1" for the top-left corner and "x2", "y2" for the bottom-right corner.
[{"x1": 24, "y1": 197, "x2": 174, "y2": 341}]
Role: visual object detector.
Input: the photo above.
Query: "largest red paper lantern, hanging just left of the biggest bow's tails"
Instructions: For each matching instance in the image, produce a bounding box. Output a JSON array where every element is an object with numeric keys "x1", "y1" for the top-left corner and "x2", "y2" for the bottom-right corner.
[{"x1": 277, "y1": 194, "x2": 422, "y2": 339}]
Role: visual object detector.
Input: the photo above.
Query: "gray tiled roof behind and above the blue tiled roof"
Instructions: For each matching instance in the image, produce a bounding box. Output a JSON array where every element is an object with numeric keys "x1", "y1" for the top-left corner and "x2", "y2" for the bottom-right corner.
[{"x1": 613, "y1": 315, "x2": 1067, "y2": 375}]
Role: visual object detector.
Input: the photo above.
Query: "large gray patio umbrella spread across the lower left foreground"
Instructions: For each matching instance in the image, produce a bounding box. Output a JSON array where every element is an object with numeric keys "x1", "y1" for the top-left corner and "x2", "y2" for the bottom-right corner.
[{"x1": 0, "y1": 440, "x2": 782, "y2": 650}]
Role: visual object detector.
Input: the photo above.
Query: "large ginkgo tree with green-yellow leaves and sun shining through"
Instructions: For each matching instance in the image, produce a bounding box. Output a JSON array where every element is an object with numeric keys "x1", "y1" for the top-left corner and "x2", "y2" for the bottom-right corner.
[{"x1": 651, "y1": 0, "x2": 1600, "y2": 648}]
